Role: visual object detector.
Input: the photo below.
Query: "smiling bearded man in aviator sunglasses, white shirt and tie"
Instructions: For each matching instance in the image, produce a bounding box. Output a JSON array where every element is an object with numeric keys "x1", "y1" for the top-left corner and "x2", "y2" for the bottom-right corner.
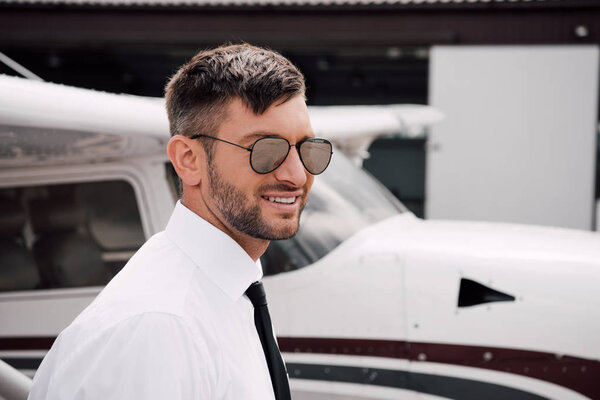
[{"x1": 30, "y1": 44, "x2": 331, "y2": 400}]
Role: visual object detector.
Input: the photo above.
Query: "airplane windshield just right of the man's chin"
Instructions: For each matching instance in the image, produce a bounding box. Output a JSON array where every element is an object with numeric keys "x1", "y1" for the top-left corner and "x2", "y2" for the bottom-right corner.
[{"x1": 261, "y1": 152, "x2": 405, "y2": 275}]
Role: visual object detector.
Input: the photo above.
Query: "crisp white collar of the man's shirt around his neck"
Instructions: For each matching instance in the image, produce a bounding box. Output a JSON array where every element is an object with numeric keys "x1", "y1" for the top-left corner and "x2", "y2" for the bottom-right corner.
[{"x1": 165, "y1": 201, "x2": 263, "y2": 301}]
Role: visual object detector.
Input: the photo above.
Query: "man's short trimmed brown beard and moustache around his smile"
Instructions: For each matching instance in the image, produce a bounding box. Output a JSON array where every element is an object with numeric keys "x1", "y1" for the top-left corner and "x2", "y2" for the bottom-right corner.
[{"x1": 209, "y1": 167, "x2": 307, "y2": 240}]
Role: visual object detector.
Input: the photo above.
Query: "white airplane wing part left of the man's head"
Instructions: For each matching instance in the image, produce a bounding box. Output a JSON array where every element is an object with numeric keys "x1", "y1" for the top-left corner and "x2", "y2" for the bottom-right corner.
[{"x1": 0, "y1": 75, "x2": 169, "y2": 168}]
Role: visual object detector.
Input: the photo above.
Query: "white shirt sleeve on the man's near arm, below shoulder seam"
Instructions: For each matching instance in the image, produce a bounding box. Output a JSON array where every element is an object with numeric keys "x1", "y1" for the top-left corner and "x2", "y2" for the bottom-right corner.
[{"x1": 29, "y1": 313, "x2": 219, "y2": 400}]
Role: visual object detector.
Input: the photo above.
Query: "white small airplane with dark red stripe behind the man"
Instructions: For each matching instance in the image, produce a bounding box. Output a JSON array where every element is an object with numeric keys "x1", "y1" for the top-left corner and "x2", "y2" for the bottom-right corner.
[{"x1": 0, "y1": 76, "x2": 600, "y2": 400}]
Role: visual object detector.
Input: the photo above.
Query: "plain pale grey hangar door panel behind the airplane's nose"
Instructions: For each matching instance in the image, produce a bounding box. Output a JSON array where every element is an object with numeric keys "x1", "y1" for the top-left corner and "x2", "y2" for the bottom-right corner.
[{"x1": 425, "y1": 46, "x2": 599, "y2": 230}]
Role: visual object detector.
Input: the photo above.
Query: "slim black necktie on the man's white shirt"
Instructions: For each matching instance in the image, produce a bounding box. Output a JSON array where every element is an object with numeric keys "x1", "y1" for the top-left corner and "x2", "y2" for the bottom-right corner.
[{"x1": 246, "y1": 282, "x2": 292, "y2": 400}]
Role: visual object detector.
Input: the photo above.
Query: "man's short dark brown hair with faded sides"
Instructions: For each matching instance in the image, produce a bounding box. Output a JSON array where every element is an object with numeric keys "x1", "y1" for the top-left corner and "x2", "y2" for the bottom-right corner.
[{"x1": 165, "y1": 44, "x2": 306, "y2": 153}]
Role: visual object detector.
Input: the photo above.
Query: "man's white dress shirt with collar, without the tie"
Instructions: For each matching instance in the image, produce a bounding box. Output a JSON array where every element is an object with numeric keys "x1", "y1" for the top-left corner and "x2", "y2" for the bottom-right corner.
[{"x1": 29, "y1": 202, "x2": 274, "y2": 400}]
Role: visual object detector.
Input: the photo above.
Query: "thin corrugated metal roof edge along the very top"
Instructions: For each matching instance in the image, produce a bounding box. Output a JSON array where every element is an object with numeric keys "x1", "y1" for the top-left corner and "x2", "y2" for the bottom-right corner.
[{"x1": 0, "y1": 0, "x2": 577, "y2": 7}]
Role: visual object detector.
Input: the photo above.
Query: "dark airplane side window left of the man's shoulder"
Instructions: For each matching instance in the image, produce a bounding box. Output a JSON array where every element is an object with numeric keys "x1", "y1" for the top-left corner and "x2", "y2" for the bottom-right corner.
[{"x1": 0, "y1": 181, "x2": 144, "y2": 292}]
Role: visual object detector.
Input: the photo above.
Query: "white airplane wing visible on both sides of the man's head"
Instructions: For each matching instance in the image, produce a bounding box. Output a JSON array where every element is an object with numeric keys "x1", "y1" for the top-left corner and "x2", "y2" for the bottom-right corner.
[{"x1": 0, "y1": 75, "x2": 442, "y2": 168}]
